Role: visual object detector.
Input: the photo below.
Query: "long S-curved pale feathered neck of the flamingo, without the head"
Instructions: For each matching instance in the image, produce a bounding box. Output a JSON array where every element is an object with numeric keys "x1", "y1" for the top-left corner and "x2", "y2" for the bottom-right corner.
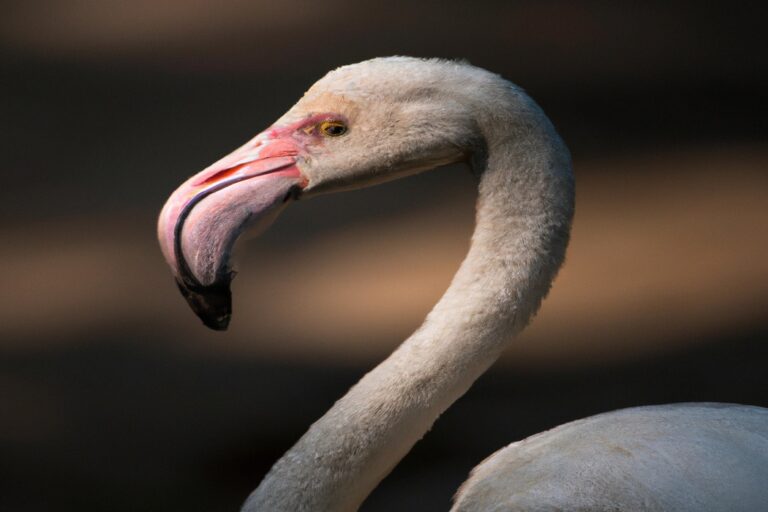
[{"x1": 243, "y1": 93, "x2": 573, "y2": 512}]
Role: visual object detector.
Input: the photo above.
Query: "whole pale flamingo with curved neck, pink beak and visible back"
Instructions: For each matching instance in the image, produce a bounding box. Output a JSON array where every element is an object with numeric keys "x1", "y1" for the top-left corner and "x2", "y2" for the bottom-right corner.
[{"x1": 158, "y1": 57, "x2": 768, "y2": 512}]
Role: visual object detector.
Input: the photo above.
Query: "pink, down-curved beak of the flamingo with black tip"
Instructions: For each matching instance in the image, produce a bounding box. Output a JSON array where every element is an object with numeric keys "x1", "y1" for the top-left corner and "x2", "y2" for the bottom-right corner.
[{"x1": 158, "y1": 131, "x2": 307, "y2": 330}]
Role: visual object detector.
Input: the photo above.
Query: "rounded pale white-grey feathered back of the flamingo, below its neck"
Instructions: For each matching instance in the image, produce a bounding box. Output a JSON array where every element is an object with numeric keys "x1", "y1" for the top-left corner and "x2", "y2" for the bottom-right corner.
[{"x1": 452, "y1": 403, "x2": 768, "y2": 512}]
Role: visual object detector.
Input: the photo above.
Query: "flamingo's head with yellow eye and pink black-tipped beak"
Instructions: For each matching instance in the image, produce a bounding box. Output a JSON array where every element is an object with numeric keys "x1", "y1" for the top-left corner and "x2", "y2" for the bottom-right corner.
[{"x1": 158, "y1": 57, "x2": 484, "y2": 330}]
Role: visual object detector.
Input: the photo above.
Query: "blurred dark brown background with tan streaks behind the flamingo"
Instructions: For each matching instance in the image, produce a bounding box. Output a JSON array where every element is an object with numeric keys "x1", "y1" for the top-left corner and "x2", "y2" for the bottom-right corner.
[{"x1": 0, "y1": 0, "x2": 768, "y2": 512}]
